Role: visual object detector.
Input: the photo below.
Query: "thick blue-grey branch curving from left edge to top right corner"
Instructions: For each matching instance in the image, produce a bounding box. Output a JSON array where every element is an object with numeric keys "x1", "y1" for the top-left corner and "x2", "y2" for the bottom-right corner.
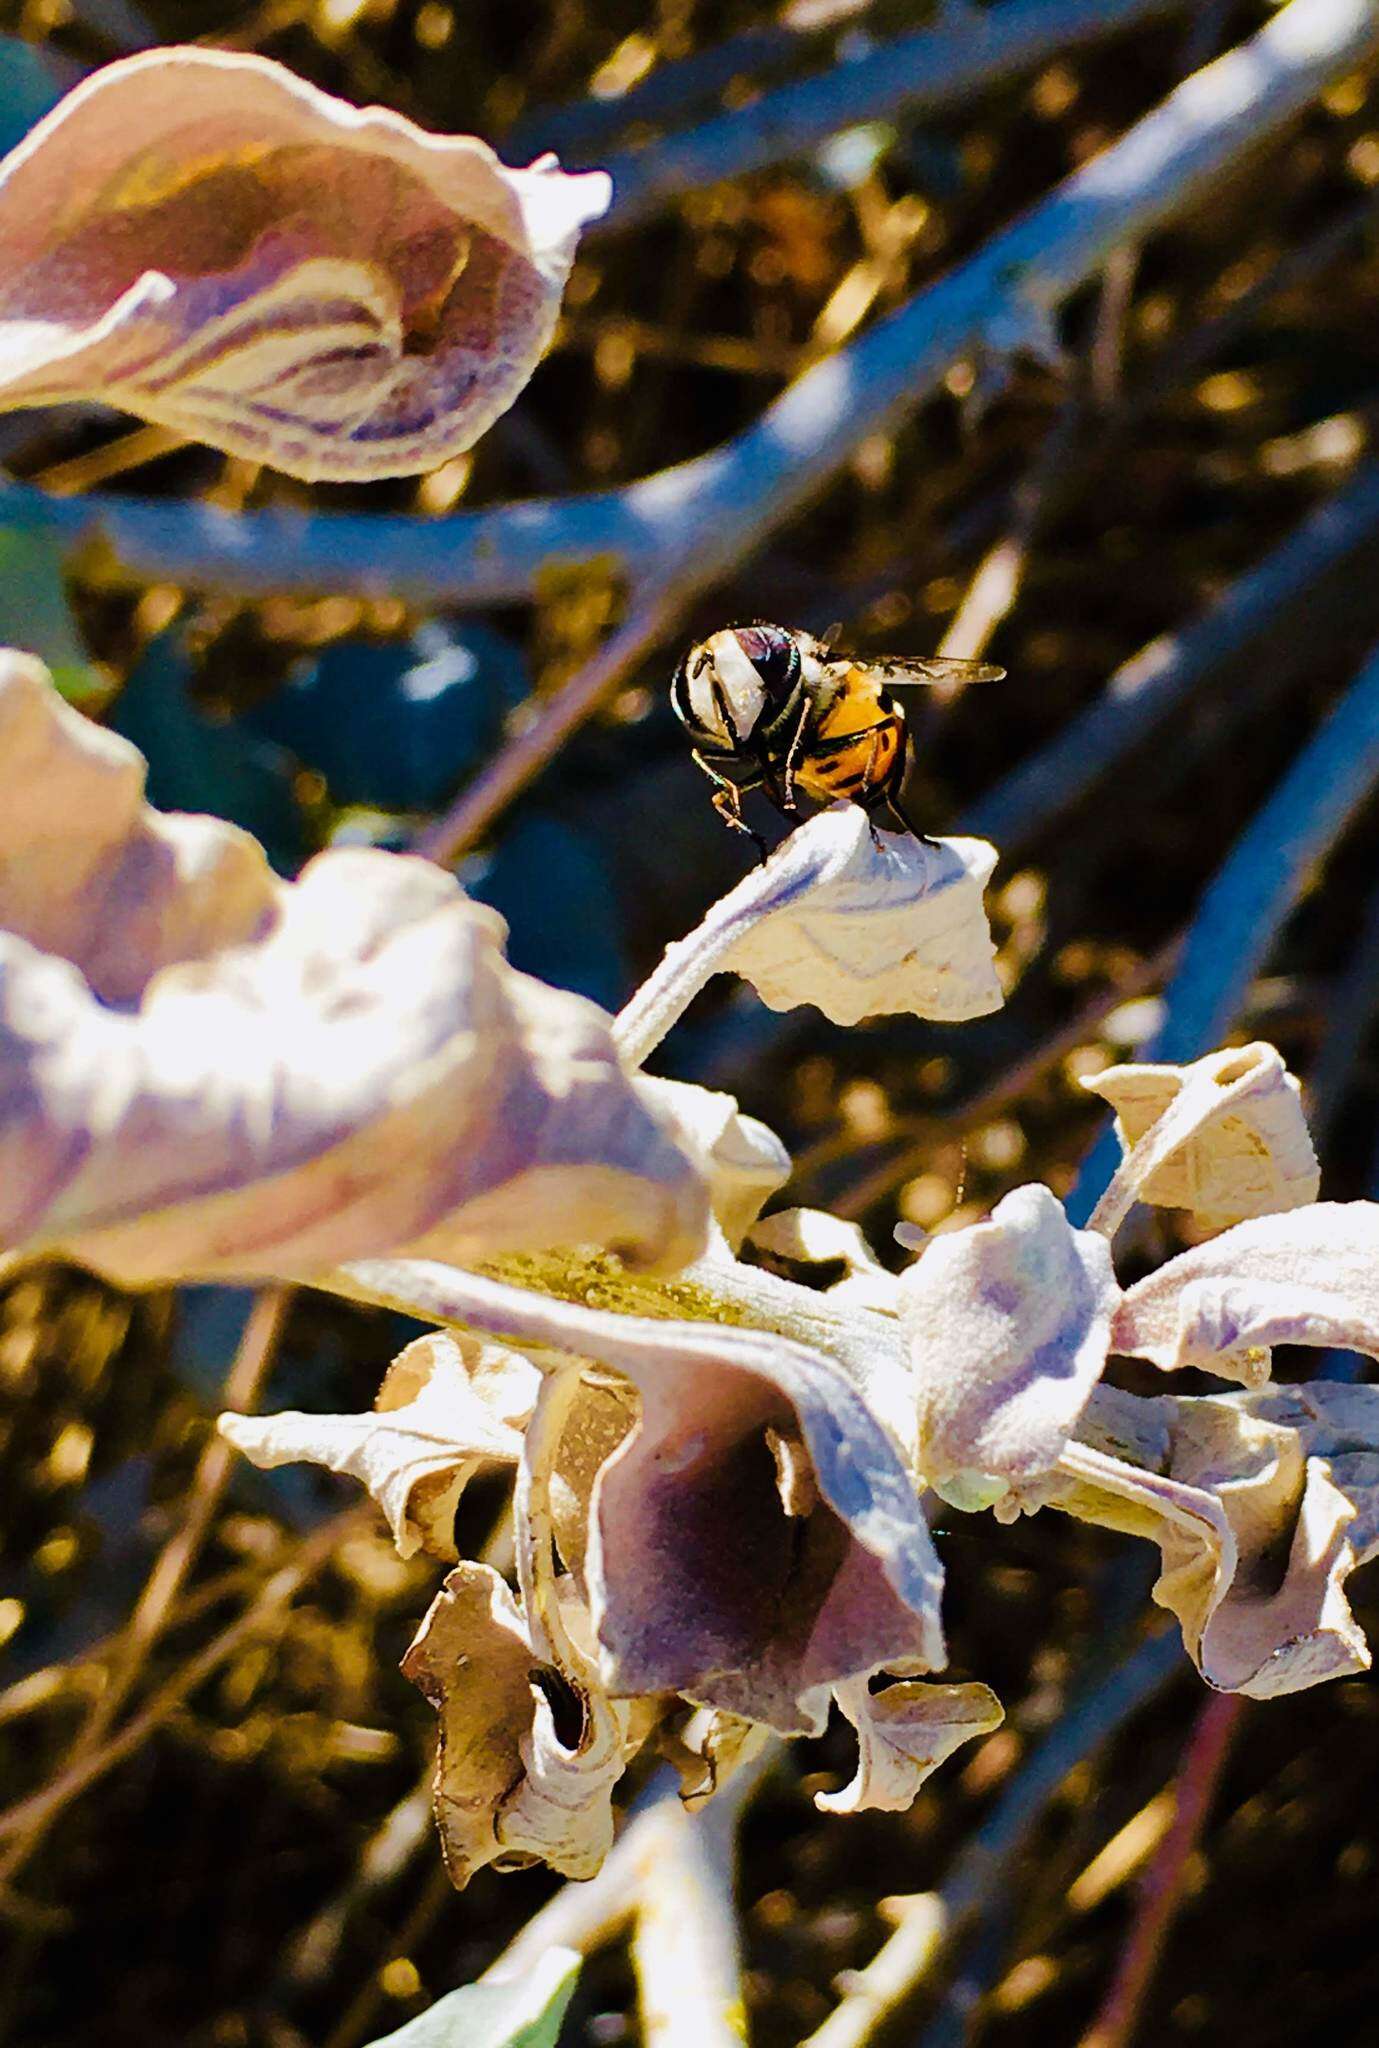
[{"x1": 0, "y1": 0, "x2": 1379, "y2": 614}]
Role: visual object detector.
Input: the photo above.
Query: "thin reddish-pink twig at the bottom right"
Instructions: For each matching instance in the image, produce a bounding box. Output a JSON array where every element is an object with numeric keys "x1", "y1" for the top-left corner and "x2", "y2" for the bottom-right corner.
[{"x1": 1080, "y1": 1694, "x2": 1246, "y2": 2048}]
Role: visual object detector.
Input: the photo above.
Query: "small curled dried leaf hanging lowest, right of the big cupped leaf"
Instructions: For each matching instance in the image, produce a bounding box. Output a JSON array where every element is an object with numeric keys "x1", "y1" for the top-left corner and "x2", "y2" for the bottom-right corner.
[{"x1": 813, "y1": 1679, "x2": 1006, "y2": 1812}]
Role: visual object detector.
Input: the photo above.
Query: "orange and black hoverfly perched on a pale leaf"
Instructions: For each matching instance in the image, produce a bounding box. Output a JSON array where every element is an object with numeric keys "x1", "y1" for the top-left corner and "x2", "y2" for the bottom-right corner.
[{"x1": 670, "y1": 621, "x2": 1006, "y2": 858}]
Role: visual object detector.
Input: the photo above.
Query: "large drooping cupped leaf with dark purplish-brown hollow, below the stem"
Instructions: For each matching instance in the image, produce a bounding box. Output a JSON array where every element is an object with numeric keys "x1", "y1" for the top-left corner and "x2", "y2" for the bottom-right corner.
[{"x1": 364, "y1": 1272, "x2": 945, "y2": 1733}]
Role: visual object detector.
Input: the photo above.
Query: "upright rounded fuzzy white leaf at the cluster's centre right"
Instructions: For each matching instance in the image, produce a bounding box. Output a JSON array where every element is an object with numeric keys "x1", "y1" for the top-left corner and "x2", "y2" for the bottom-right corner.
[{"x1": 900, "y1": 1186, "x2": 1119, "y2": 1507}]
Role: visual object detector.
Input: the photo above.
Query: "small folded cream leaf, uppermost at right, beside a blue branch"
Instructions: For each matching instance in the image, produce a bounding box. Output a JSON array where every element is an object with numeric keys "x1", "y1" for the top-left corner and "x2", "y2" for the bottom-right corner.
[{"x1": 1082, "y1": 1042, "x2": 1322, "y2": 1231}]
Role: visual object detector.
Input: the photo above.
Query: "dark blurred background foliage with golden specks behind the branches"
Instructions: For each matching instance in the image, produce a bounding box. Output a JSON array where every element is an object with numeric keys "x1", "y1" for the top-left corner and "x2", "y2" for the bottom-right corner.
[{"x1": 0, "y1": 0, "x2": 1379, "y2": 2048}]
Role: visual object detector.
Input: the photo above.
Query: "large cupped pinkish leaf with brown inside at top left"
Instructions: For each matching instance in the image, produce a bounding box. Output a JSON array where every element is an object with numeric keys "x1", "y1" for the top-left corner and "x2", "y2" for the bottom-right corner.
[{"x1": 0, "y1": 49, "x2": 611, "y2": 479}]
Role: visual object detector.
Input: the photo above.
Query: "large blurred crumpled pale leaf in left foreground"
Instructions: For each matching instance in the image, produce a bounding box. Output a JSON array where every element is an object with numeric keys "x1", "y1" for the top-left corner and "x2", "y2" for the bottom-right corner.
[{"x1": 0, "y1": 655, "x2": 707, "y2": 1284}]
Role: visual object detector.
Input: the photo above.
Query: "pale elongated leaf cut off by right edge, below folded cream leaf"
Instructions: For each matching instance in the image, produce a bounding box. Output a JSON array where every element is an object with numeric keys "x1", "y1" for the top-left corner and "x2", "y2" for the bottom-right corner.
[{"x1": 1113, "y1": 1202, "x2": 1379, "y2": 1384}]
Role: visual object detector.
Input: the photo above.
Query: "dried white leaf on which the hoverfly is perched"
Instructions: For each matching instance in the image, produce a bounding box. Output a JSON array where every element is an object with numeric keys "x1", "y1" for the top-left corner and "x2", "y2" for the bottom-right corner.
[{"x1": 615, "y1": 803, "x2": 1004, "y2": 1065}]
